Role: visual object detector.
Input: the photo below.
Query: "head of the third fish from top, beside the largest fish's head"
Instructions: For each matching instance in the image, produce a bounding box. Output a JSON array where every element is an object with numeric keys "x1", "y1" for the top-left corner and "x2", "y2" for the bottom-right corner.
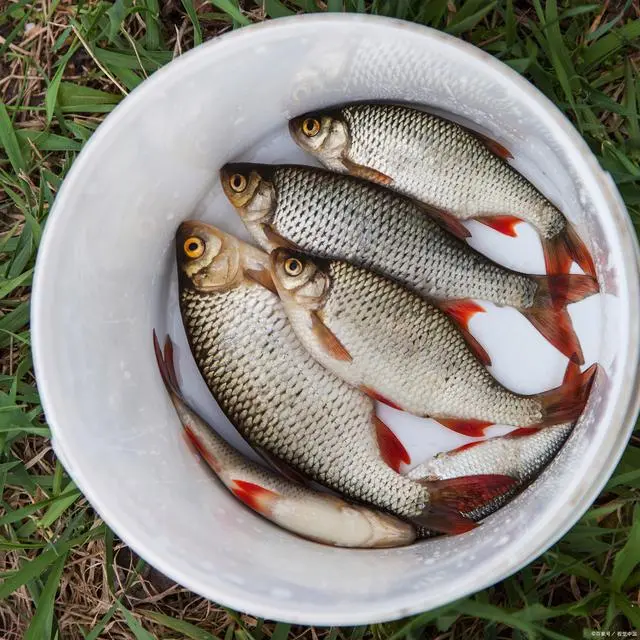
[{"x1": 271, "y1": 247, "x2": 331, "y2": 311}]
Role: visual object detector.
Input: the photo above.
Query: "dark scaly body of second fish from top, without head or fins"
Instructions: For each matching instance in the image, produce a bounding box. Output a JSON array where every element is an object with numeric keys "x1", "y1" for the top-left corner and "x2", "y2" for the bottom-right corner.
[{"x1": 271, "y1": 166, "x2": 538, "y2": 308}]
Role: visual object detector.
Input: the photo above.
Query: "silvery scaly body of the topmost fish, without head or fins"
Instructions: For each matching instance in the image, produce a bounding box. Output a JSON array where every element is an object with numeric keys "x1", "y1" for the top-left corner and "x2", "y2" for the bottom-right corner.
[{"x1": 340, "y1": 104, "x2": 566, "y2": 238}]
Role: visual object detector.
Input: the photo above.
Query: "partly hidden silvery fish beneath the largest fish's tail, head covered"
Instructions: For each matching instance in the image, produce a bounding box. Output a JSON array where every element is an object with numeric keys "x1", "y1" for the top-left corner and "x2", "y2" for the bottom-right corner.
[{"x1": 407, "y1": 423, "x2": 574, "y2": 538}]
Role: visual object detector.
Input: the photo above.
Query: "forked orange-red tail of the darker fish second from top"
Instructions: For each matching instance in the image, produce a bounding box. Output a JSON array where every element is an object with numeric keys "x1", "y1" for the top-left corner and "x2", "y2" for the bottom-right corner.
[{"x1": 520, "y1": 274, "x2": 598, "y2": 364}]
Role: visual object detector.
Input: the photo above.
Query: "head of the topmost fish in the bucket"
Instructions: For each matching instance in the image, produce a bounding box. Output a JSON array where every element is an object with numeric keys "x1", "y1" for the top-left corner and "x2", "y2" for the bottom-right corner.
[{"x1": 289, "y1": 111, "x2": 350, "y2": 172}]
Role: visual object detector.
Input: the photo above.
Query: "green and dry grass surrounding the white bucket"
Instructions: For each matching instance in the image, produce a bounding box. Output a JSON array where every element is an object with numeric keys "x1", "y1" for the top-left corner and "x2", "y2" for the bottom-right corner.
[{"x1": 0, "y1": 0, "x2": 640, "y2": 640}]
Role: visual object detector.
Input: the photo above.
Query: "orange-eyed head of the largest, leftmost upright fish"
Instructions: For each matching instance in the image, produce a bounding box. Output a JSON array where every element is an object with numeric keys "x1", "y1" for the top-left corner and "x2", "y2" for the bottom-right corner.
[{"x1": 176, "y1": 220, "x2": 248, "y2": 293}]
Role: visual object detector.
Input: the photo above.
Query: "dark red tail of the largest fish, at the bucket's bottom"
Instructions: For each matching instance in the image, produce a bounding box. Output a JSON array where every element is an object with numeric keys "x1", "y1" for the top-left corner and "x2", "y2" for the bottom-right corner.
[{"x1": 412, "y1": 474, "x2": 518, "y2": 534}]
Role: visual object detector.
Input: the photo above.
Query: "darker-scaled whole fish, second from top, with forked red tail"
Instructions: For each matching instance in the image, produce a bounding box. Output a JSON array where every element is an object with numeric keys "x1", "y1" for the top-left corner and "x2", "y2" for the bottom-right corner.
[{"x1": 220, "y1": 163, "x2": 598, "y2": 366}]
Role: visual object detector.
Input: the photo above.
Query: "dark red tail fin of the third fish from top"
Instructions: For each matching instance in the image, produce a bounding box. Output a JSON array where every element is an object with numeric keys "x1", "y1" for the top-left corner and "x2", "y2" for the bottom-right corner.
[{"x1": 534, "y1": 364, "x2": 598, "y2": 427}]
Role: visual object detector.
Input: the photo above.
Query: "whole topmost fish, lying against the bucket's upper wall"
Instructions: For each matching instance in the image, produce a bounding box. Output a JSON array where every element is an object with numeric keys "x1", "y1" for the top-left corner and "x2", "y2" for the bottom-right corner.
[{"x1": 289, "y1": 104, "x2": 596, "y2": 276}]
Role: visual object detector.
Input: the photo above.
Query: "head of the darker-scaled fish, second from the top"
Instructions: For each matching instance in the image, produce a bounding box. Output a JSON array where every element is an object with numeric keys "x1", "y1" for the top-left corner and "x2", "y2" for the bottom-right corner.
[{"x1": 220, "y1": 162, "x2": 276, "y2": 227}]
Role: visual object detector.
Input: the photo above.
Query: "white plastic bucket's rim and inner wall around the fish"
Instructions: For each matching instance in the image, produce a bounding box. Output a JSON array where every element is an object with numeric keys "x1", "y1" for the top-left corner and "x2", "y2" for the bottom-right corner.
[{"x1": 32, "y1": 15, "x2": 640, "y2": 625}]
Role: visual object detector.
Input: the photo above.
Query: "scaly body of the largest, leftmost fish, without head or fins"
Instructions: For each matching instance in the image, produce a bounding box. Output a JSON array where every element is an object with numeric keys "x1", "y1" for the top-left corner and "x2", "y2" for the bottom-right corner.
[{"x1": 180, "y1": 283, "x2": 428, "y2": 517}]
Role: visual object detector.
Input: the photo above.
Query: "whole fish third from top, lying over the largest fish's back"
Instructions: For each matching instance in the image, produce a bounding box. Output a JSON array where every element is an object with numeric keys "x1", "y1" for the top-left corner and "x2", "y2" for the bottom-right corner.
[{"x1": 271, "y1": 247, "x2": 597, "y2": 436}]
